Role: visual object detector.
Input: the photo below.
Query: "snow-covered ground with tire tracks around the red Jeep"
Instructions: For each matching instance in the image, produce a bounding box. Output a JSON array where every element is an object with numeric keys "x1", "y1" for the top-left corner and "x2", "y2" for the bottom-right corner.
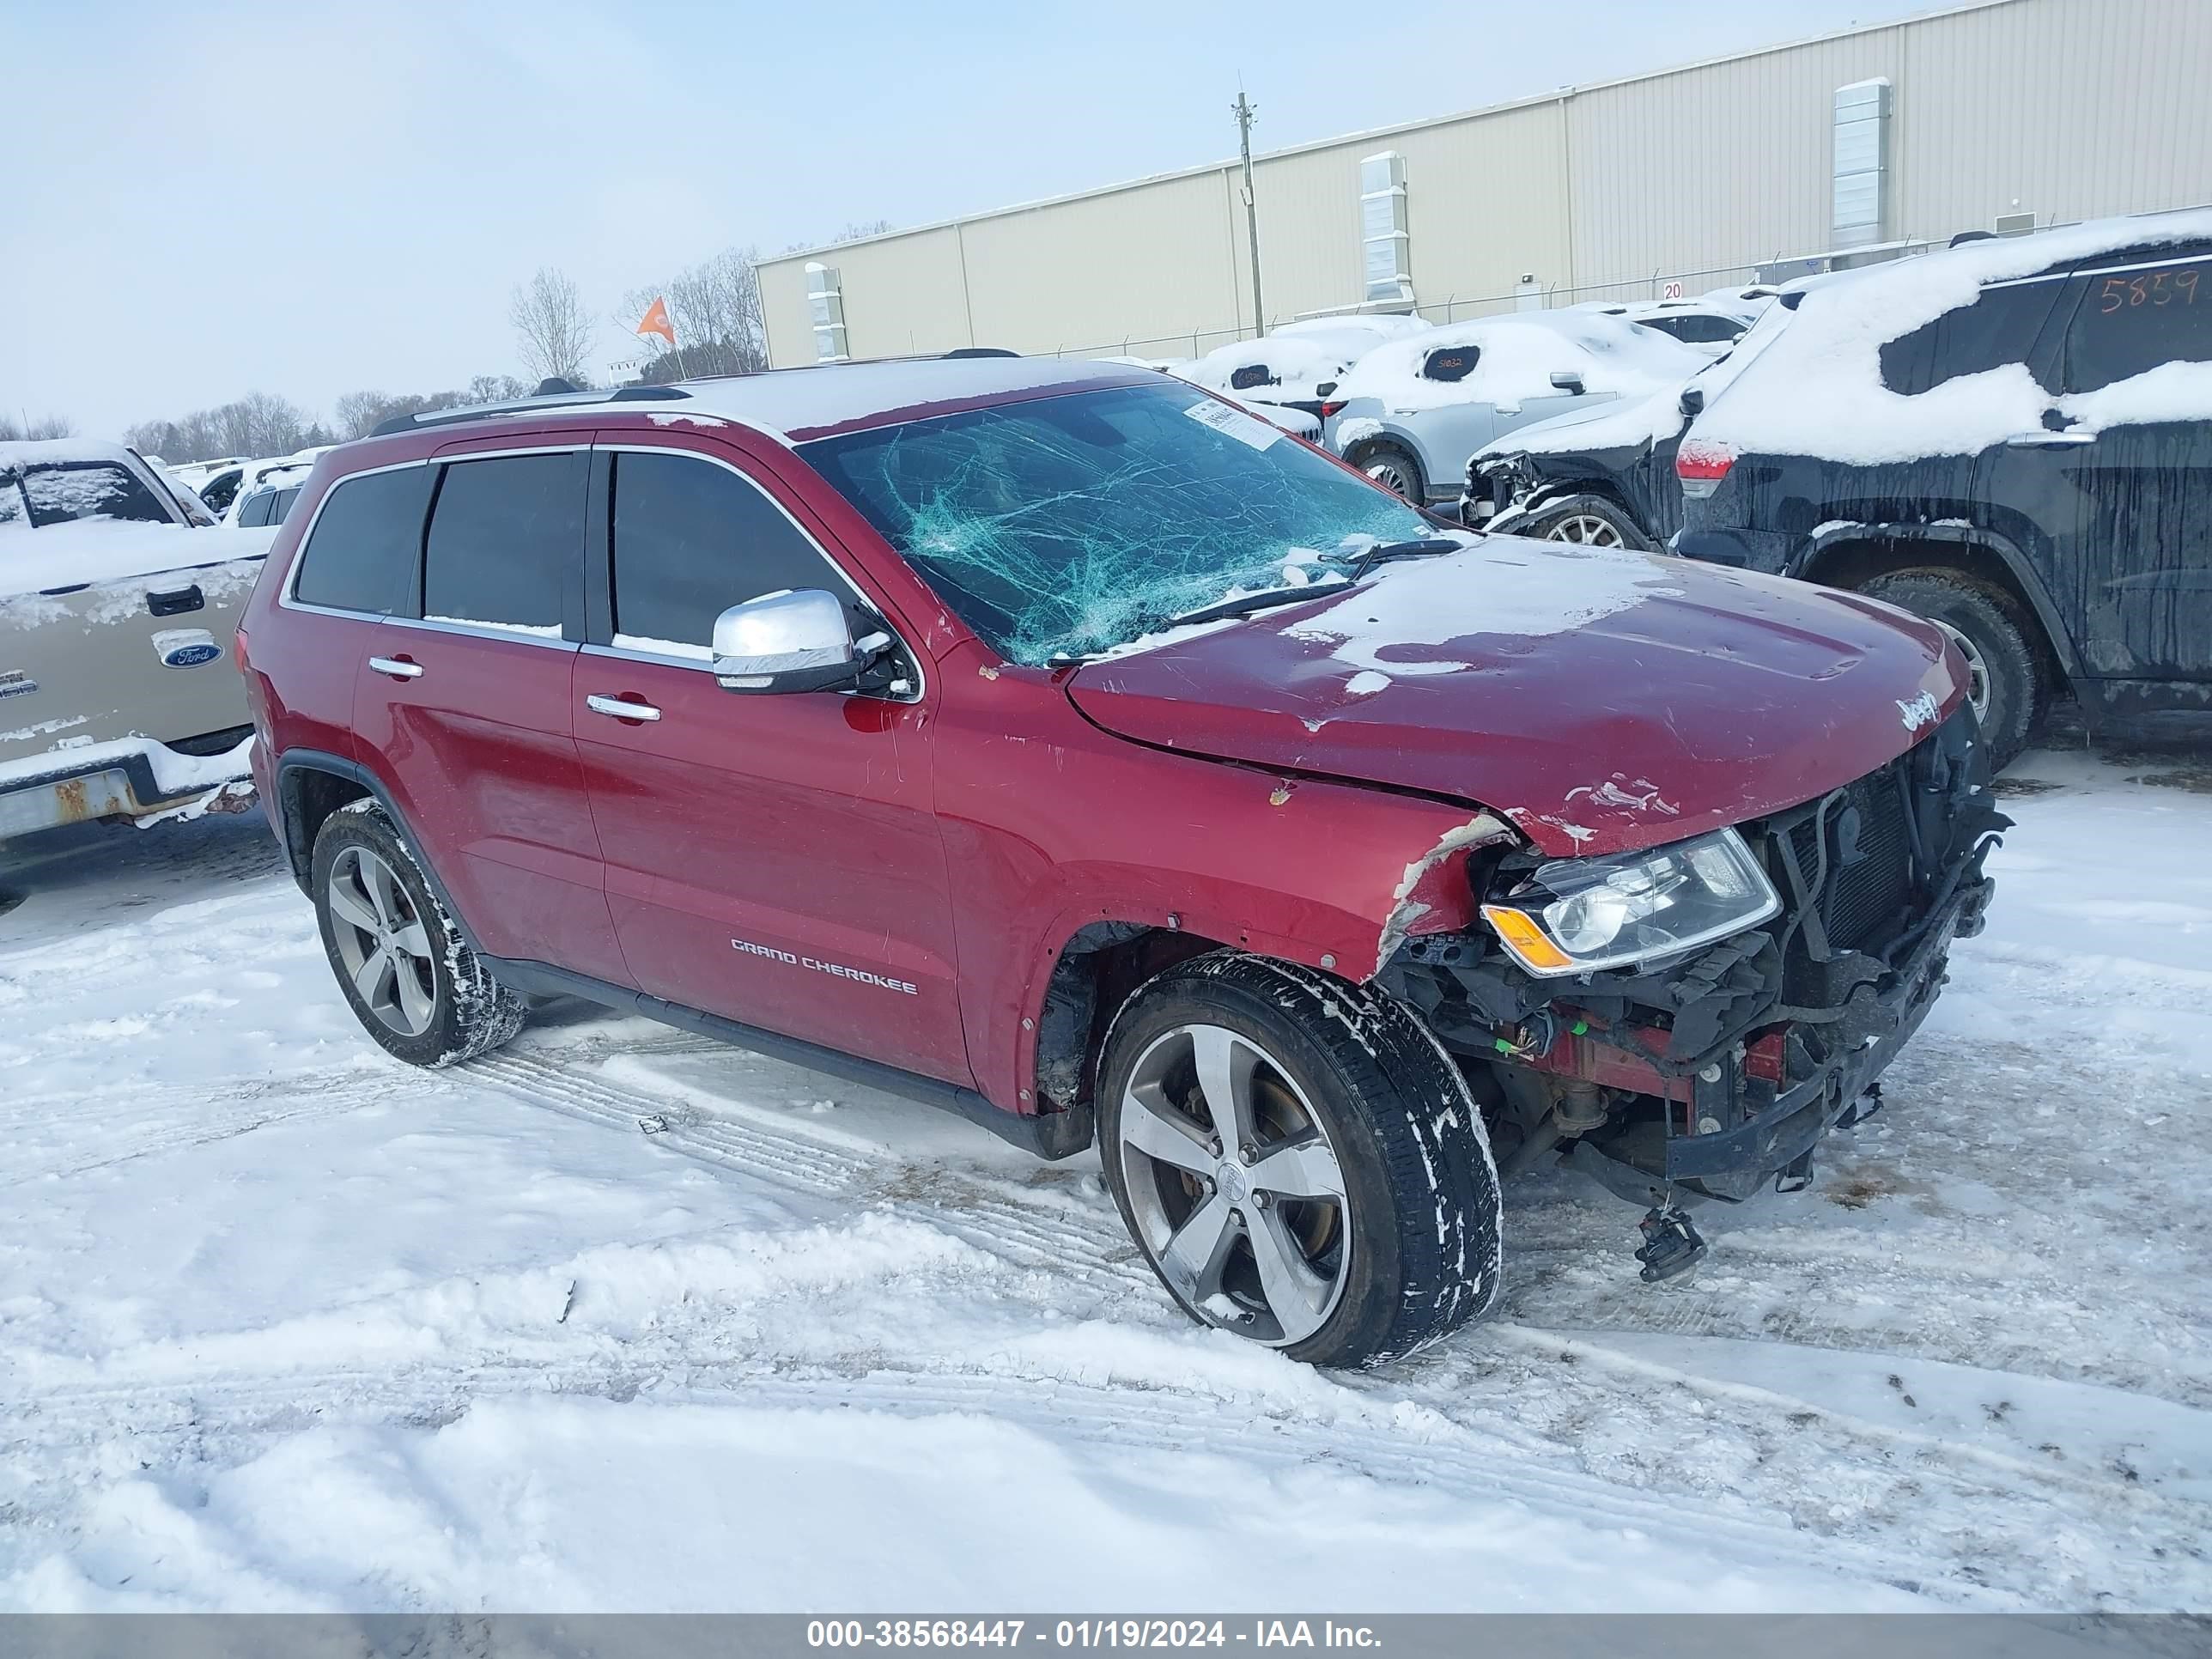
[{"x1": 0, "y1": 725, "x2": 2212, "y2": 1613}]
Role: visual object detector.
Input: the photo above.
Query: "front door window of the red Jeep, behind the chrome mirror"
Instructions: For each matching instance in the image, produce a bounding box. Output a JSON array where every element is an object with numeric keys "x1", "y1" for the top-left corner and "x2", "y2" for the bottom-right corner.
[{"x1": 615, "y1": 452, "x2": 852, "y2": 648}]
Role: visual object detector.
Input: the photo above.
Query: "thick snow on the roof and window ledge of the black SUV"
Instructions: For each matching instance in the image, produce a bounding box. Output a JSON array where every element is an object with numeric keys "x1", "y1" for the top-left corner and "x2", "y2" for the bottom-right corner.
[{"x1": 1687, "y1": 210, "x2": 2212, "y2": 467}]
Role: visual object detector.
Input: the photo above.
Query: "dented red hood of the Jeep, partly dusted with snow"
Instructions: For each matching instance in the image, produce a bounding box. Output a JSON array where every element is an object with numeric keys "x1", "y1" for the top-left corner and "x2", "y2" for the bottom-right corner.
[{"x1": 1068, "y1": 535, "x2": 1964, "y2": 858}]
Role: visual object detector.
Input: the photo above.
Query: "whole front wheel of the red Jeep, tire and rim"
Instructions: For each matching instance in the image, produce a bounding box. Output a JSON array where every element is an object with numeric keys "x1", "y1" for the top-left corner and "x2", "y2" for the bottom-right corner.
[{"x1": 1097, "y1": 951, "x2": 1502, "y2": 1367}]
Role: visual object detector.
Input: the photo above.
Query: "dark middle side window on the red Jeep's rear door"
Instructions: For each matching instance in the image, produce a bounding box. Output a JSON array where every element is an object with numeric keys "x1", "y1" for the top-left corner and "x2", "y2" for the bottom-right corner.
[{"x1": 422, "y1": 452, "x2": 588, "y2": 633}]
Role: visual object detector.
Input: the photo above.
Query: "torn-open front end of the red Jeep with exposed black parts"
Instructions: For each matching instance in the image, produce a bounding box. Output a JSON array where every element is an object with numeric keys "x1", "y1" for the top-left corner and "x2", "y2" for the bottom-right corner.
[{"x1": 1378, "y1": 710, "x2": 2008, "y2": 1203}]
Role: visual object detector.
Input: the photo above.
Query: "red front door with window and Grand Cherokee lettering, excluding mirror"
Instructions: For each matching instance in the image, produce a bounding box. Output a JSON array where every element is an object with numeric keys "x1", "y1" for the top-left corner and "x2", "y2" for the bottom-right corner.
[{"x1": 571, "y1": 434, "x2": 971, "y2": 1084}]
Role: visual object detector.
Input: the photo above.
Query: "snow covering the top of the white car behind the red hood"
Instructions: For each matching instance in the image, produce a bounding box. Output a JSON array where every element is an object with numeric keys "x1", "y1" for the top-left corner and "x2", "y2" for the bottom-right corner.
[{"x1": 1336, "y1": 312, "x2": 1712, "y2": 411}]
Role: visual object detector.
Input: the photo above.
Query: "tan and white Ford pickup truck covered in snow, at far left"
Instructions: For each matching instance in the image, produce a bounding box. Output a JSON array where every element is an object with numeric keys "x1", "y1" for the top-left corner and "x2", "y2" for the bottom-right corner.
[{"x1": 0, "y1": 438, "x2": 274, "y2": 841}]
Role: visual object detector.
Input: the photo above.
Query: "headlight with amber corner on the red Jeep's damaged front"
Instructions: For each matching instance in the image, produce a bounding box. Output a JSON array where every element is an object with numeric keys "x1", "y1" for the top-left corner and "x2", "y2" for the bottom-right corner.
[{"x1": 1482, "y1": 830, "x2": 1781, "y2": 978}]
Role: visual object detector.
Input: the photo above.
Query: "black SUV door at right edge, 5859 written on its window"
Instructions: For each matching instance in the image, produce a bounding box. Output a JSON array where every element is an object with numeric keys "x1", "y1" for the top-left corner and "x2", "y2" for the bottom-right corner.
[{"x1": 2044, "y1": 252, "x2": 2212, "y2": 681}]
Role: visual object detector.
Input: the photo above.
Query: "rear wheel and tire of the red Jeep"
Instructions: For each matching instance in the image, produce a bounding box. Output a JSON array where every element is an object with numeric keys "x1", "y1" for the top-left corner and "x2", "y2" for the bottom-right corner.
[{"x1": 310, "y1": 801, "x2": 526, "y2": 1066}]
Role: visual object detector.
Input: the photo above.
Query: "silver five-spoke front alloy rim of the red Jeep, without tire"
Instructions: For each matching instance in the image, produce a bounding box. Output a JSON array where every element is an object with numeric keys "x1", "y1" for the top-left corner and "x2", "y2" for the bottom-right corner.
[{"x1": 1117, "y1": 1024, "x2": 1354, "y2": 1347}]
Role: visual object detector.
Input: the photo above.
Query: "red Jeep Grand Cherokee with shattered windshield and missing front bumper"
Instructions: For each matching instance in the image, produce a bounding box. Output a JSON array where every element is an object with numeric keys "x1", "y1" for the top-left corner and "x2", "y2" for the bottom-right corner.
[{"x1": 239, "y1": 358, "x2": 2004, "y2": 1364}]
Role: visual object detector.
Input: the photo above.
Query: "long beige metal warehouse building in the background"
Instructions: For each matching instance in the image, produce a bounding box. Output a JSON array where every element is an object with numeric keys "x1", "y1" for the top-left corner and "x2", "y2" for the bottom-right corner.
[{"x1": 761, "y1": 0, "x2": 2212, "y2": 365}]
